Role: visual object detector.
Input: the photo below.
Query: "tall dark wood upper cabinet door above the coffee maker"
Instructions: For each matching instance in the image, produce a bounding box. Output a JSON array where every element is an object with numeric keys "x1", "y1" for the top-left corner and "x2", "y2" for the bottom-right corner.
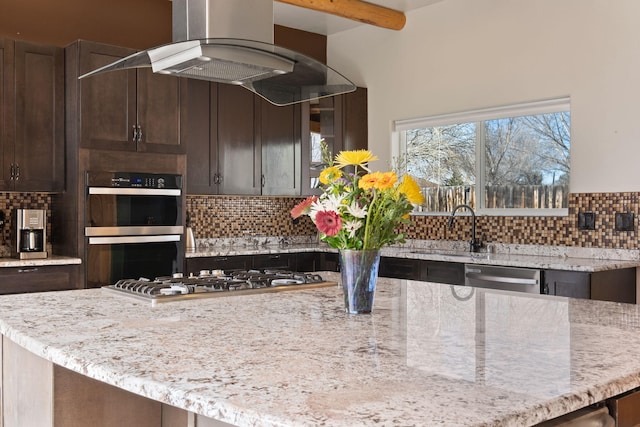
[{"x1": 14, "y1": 41, "x2": 64, "y2": 191}]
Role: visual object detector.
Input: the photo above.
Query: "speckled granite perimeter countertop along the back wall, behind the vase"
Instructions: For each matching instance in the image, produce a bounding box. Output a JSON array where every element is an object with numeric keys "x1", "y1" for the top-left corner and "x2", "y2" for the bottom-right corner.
[{"x1": 185, "y1": 243, "x2": 640, "y2": 273}]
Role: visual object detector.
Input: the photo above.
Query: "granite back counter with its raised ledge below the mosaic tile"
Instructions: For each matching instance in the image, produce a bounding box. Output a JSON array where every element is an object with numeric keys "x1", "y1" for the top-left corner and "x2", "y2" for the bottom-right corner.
[{"x1": 186, "y1": 236, "x2": 640, "y2": 272}]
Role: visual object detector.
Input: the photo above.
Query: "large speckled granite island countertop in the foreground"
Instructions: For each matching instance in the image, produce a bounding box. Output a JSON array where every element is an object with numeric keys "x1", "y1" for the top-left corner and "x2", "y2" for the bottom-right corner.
[{"x1": 0, "y1": 272, "x2": 640, "y2": 427}]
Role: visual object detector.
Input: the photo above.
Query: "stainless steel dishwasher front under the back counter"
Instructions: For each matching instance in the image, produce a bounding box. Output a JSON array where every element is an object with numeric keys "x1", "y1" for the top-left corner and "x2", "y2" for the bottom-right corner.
[{"x1": 464, "y1": 264, "x2": 541, "y2": 294}]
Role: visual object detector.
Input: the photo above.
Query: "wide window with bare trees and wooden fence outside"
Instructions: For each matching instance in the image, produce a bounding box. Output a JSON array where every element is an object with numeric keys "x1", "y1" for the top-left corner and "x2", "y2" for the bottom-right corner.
[{"x1": 395, "y1": 98, "x2": 571, "y2": 215}]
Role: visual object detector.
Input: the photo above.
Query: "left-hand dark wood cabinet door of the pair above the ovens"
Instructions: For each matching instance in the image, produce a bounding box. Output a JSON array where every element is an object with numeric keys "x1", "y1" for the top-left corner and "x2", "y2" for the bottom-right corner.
[{"x1": 78, "y1": 41, "x2": 137, "y2": 151}]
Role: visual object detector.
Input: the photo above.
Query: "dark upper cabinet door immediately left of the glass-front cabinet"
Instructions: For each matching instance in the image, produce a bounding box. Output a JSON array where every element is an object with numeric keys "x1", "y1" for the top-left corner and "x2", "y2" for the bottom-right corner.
[{"x1": 260, "y1": 100, "x2": 301, "y2": 196}]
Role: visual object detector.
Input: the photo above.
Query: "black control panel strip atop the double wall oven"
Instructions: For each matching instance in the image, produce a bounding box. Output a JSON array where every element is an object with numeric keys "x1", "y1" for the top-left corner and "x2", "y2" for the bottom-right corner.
[{"x1": 87, "y1": 172, "x2": 182, "y2": 189}]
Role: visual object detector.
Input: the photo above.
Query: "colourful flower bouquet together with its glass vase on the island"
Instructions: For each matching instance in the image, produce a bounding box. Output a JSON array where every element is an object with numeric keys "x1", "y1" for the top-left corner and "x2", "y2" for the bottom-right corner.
[{"x1": 291, "y1": 144, "x2": 424, "y2": 313}]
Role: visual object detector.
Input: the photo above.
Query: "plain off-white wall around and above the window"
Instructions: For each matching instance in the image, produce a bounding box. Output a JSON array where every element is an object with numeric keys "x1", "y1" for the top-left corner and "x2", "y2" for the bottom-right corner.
[{"x1": 328, "y1": 0, "x2": 640, "y2": 193}]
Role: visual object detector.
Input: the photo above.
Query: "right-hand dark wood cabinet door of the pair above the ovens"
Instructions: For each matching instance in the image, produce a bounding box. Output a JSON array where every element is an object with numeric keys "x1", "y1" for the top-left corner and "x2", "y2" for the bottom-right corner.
[{"x1": 137, "y1": 68, "x2": 186, "y2": 153}]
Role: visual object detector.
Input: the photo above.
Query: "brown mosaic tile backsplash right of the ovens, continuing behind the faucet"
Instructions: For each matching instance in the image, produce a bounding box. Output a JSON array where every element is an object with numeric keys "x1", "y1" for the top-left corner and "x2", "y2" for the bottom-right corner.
[{"x1": 182, "y1": 192, "x2": 640, "y2": 249}]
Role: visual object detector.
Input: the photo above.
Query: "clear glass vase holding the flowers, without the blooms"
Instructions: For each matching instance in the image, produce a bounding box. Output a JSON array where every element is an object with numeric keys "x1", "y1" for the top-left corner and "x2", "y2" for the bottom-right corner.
[{"x1": 340, "y1": 249, "x2": 380, "y2": 314}]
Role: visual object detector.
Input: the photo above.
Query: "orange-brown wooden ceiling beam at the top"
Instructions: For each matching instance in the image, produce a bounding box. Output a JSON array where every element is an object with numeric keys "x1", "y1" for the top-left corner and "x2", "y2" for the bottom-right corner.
[{"x1": 275, "y1": 0, "x2": 406, "y2": 30}]
